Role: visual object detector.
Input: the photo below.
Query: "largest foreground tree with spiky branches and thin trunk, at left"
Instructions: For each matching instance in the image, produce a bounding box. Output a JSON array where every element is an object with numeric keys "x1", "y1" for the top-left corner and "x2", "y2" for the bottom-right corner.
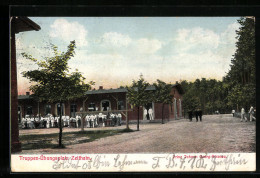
[{"x1": 22, "y1": 41, "x2": 92, "y2": 148}]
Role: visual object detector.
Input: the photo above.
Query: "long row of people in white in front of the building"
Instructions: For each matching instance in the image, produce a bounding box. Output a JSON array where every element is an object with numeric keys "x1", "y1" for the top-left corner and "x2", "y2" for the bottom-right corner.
[{"x1": 21, "y1": 113, "x2": 122, "y2": 129}]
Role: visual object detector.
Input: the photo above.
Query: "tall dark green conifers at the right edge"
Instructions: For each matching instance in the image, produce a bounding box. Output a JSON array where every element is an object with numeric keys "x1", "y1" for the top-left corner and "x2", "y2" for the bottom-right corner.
[{"x1": 224, "y1": 18, "x2": 256, "y2": 109}]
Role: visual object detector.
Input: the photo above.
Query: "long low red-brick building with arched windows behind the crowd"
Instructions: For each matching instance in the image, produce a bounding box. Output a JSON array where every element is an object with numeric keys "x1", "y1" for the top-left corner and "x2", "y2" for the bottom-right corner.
[{"x1": 18, "y1": 83, "x2": 183, "y2": 122}]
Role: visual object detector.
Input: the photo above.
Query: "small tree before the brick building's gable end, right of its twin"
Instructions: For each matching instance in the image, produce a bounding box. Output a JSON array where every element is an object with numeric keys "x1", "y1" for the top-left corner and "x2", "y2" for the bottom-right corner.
[{"x1": 153, "y1": 79, "x2": 174, "y2": 124}]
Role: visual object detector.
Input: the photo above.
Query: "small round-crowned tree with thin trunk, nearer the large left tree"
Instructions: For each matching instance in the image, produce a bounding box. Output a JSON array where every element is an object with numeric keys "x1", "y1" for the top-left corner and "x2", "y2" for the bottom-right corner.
[{"x1": 127, "y1": 75, "x2": 151, "y2": 130}]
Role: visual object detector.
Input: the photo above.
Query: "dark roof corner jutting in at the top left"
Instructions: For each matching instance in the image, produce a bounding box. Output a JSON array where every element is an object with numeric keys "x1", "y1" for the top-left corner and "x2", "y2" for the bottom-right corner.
[{"x1": 11, "y1": 17, "x2": 41, "y2": 33}]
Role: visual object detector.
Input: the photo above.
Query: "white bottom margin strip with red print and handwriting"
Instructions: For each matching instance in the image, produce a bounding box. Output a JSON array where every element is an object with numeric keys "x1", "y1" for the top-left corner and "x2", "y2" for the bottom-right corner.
[{"x1": 11, "y1": 153, "x2": 256, "y2": 172}]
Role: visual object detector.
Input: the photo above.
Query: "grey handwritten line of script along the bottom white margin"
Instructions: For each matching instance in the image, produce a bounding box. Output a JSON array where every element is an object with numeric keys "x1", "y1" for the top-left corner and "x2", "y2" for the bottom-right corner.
[{"x1": 49, "y1": 154, "x2": 248, "y2": 171}]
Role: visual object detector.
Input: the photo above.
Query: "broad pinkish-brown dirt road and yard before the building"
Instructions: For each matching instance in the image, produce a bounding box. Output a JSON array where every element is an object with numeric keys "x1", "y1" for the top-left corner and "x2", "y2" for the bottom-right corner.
[{"x1": 20, "y1": 114, "x2": 255, "y2": 153}]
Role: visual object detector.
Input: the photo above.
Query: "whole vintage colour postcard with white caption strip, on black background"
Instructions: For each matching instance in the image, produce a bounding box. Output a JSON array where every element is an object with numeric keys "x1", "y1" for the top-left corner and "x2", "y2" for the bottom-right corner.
[{"x1": 10, "y1": 16, "x2": 256, "y2": 172}]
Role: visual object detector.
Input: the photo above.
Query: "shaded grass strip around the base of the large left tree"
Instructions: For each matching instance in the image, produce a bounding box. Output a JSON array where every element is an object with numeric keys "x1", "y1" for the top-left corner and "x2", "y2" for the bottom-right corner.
[{"x1": 19, "y1": 129, "x2": 133, "y2": 150}]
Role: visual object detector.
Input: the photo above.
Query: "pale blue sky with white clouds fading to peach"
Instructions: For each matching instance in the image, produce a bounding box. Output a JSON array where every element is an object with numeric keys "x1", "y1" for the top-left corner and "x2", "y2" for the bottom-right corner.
[{"x1": 16, "y1": 17, "x2": 239, "y2": 95}]
